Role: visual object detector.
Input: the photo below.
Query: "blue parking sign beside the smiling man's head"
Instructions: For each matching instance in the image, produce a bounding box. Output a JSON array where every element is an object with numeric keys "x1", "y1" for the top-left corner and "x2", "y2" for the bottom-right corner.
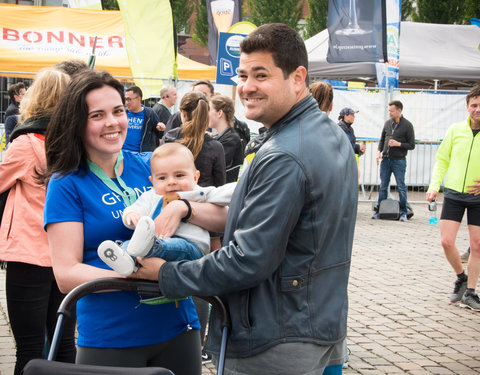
[{"x1": 216, "y1": 33, "x2": 247, "y2": 86}]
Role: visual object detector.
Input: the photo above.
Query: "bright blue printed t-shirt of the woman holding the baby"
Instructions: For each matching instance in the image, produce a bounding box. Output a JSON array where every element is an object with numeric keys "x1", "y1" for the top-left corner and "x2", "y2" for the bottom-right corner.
[{"x1": 44, "y1": 151, "x2": 200, "y2": 348}]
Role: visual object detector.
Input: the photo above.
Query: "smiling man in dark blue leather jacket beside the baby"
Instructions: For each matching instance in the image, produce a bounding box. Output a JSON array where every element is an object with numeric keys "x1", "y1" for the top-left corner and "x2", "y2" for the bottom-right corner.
[{"x1": 133, "y1": 24, "x2": 358, "y2": 375}]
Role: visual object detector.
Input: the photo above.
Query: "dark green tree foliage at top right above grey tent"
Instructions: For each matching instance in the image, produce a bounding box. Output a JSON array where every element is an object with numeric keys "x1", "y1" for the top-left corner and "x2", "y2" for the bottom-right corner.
[{"x1": 413, "y1": 0, "x2": 466, "y2": 24}]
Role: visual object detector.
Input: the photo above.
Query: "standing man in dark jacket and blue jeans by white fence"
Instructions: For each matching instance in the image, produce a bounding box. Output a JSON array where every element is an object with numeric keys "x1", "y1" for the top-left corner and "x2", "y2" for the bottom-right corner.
[{"x1": 372, "y1": 100, "x2": 415, "y2": 221}]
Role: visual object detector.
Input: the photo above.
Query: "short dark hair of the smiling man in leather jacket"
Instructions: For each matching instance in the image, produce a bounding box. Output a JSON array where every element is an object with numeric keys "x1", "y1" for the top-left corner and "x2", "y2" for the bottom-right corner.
[{"x1": 240, "y1": 23, "x2": 308, "y2": 81}]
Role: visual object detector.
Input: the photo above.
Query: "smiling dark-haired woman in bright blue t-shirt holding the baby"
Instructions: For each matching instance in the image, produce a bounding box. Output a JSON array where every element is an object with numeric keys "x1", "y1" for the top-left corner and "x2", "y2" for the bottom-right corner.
[{"x1": 44, "y1": 70, "x2": 222, "y2": 375}]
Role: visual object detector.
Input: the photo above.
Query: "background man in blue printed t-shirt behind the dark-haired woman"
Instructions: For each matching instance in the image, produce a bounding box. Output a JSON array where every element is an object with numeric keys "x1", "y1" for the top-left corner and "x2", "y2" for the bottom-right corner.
[{"x1": 123, "y1": 86, "x2": 163, "y2": 152}]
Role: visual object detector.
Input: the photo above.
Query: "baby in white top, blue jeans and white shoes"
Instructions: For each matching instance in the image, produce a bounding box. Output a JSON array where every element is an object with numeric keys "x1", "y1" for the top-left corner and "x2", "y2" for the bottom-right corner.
[{"x1": 97, "y1": 143, "x2": 236, "y2": 276}]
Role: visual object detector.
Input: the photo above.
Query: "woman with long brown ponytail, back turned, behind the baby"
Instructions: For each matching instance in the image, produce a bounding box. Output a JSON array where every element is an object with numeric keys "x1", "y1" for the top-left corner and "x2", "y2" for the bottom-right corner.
[{"x1": 163, "y1": 91, "x2": 226, "y2": 186}]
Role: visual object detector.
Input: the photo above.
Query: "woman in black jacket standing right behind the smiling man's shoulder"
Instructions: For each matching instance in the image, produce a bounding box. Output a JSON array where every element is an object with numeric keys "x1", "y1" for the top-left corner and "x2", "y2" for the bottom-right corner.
[{"x1": 210, "y1": 95, "x2": 243, "y2": 182}]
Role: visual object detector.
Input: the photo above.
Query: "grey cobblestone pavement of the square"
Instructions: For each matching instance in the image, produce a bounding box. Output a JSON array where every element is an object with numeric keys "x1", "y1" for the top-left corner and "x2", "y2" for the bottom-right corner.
[{"x1": 0, "y1": 195, "x2": 480, "y2": 375}]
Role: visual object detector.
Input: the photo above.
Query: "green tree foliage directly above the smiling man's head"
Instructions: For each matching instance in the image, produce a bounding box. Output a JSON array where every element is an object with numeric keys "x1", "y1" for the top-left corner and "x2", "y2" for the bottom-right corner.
[{"x1": 245, "y1": 0, "x2": 304, "y2": 31}]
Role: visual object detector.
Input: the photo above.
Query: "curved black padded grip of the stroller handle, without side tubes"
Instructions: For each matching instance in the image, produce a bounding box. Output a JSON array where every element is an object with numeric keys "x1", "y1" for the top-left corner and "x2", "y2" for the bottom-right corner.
[{"x1": 58, "y1": 277, "x2": 230, "y2": 328}]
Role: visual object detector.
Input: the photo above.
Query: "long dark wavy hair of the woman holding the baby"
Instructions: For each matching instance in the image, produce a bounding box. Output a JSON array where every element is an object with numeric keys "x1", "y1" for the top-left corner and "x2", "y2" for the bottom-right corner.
[{"x1": 43, "y1": 70, "x2": 125, "y2": 183}]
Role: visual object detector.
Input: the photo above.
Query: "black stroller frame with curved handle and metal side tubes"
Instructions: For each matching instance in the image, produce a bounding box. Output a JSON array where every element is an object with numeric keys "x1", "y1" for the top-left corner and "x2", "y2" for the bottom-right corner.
[{"x1": 34, "y1": 277, "x2": 230, "y2": 375}]
